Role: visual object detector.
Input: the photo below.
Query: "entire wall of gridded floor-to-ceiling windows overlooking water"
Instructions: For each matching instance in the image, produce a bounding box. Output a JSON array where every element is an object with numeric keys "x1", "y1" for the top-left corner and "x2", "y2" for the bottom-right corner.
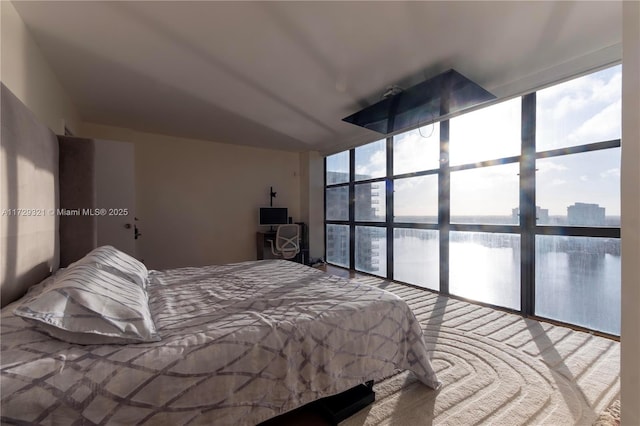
[{"x1": 325, "y1": 65, "x2": 622, "y2": 335}]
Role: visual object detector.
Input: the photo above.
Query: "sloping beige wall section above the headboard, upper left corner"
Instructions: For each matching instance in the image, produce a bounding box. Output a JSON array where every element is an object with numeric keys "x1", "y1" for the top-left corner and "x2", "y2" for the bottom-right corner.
[{"x1": 0, "y1": 0, "x2": 80, "y2": 134}]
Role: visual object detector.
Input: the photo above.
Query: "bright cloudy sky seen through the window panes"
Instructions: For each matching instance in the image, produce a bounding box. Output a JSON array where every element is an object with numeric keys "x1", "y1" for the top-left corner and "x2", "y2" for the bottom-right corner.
[{"x1": 327, "y1": 65, "x2": 622, "y2": 216}]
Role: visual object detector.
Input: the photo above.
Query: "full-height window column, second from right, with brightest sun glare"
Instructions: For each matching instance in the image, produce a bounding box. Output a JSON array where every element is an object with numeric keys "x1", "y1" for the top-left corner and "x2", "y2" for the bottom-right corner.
[{"x1": 449, "y1": 98, "x2": 522, "y2": 310}]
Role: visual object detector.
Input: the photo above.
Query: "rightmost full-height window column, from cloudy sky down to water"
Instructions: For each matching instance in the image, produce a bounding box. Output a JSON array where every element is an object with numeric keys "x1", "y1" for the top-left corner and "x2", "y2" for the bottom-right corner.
[{"x1": 535, "y1": 66, "x2": 621, "y2": 335}]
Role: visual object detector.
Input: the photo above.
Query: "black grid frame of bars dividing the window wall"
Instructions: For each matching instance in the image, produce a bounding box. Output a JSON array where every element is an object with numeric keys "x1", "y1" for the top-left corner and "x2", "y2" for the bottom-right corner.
[{"x1": 324, "y1": 65, "x2": 621, "y2": 338}]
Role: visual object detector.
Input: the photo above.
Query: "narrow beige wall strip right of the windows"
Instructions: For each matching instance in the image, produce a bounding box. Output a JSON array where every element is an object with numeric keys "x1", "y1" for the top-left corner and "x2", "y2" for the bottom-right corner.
[{"x1": 620, "y1": 1, "x2": 640, "y2": 425}]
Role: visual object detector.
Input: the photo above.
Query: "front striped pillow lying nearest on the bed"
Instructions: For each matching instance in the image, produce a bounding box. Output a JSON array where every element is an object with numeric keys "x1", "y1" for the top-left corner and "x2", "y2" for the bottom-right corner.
[{"x1": 14, "y1": 264, "x2": 160, "y2": 345}]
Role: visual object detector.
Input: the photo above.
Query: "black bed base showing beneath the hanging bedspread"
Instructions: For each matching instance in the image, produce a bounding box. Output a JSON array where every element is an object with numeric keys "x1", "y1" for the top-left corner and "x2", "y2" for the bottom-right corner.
[{"x1": 312, "y1": 380, "x2": 376, "y2": 425}]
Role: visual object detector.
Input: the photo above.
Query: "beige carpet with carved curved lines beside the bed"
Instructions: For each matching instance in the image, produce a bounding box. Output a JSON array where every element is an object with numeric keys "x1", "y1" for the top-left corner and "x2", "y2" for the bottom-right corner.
[{"x1": 341, "y1": 278, "x2": 620, "y2": 426}]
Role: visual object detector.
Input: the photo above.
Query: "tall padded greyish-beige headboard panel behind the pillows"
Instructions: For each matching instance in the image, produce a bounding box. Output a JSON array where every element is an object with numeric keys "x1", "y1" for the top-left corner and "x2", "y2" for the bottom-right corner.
[{"x1": 0, "y1": 84, "x2": 60, "y2": 306}]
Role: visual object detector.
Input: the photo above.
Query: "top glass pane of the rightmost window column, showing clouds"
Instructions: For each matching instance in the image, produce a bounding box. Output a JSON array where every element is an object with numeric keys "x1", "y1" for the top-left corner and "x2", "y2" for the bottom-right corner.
[{"x1": 536, "y1": 65, "x2": 622, "y2": 151}]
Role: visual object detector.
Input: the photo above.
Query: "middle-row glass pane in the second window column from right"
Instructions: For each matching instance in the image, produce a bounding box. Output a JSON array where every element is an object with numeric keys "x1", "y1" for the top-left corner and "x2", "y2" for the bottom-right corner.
[{"x1": 451, "y1": 163, "x2": 520, "y2": 225}]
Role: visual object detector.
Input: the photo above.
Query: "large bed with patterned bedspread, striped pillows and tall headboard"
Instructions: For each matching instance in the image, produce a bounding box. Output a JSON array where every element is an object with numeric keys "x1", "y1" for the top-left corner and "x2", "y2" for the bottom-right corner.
[{"x1": 0, "y1": 84, "x2": 439, "y2": 425}]
